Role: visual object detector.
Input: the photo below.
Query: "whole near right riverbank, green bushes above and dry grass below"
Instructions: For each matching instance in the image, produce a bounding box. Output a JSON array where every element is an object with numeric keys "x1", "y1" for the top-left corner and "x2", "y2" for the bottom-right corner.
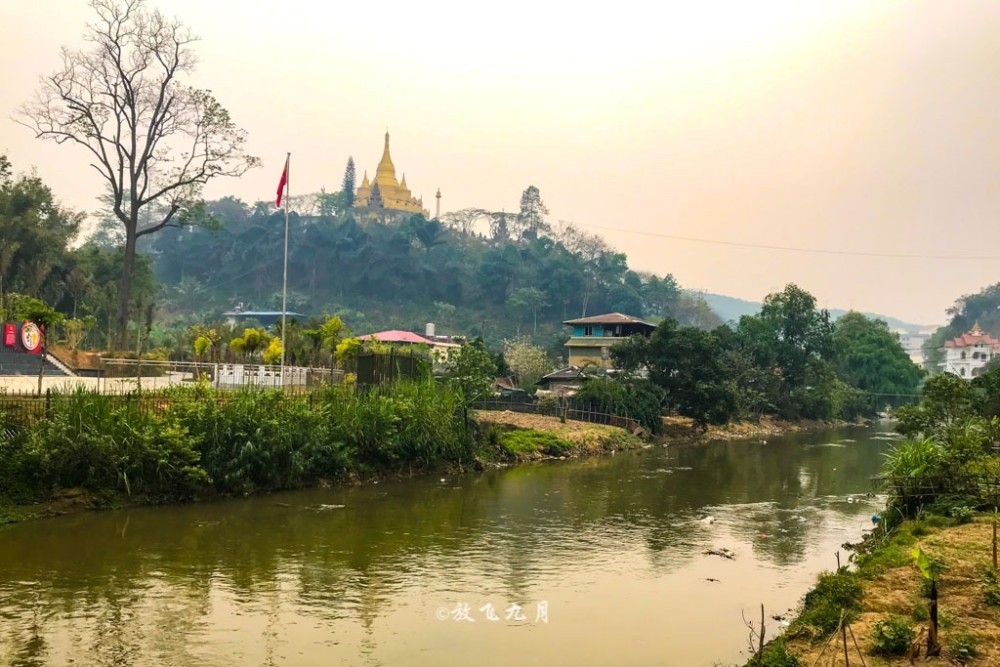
[{"x1": 747, "y1": 369, "x2": 1000, "y2": 667}]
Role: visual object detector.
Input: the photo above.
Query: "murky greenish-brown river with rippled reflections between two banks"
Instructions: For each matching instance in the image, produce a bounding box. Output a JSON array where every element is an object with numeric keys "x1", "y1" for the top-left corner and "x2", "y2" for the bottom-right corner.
[{"x1": 0, "y1": 428, "x2": 890, "y2": 667}]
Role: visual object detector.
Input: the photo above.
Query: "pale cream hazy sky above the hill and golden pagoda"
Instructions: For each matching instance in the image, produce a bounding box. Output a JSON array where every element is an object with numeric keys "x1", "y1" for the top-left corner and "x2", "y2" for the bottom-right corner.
[{"x1": 0, "y1": 0, "x2": 1000, "y2": 324}]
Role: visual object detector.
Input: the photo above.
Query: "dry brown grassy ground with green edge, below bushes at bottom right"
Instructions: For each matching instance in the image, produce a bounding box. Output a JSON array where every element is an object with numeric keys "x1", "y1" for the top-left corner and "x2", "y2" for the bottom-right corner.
[{"x1": 747, "y1": 515, "x2": 1000, "y2": 667}]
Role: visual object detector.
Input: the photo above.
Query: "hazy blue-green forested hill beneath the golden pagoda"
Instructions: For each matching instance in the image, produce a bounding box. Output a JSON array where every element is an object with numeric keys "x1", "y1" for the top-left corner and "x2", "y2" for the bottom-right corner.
[{"x1": 145, "y1": 198, "x2": 721, "y2": 351}]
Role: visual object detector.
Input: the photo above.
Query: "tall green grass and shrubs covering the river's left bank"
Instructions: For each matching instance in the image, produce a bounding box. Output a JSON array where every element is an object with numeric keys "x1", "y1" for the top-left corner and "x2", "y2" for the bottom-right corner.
[{"x1": 0, "y1": 382, "x2": 638, "y2": 523}]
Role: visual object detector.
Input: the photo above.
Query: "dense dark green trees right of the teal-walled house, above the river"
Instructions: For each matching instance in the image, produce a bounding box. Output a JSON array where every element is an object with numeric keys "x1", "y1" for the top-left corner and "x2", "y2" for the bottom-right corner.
[{"x1": 612, "y1": 285, "x2": 922, "y2": 426}]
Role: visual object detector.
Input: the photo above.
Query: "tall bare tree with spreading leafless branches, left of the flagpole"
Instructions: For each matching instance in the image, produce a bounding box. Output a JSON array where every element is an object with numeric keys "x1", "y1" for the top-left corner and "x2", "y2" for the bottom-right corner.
[{"x1": 15, "y1": 0, "x2": 260, "y2": 349}]
